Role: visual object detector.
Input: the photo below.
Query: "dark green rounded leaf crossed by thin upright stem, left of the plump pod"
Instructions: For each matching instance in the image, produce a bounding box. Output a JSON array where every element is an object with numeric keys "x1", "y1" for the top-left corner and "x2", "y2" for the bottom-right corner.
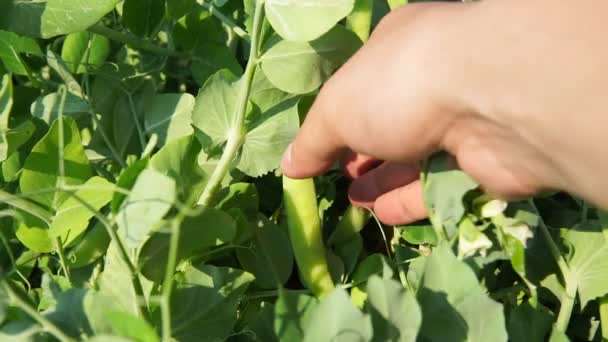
[{"x1": 138, "y1": 208, "x2": 236, "y2": 282}]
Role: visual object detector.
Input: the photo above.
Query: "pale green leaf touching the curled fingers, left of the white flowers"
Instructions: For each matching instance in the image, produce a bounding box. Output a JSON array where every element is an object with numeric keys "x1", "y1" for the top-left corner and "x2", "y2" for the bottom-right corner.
[{"x1": 423, "y1": 153, "x2": 478, "y2": 238}]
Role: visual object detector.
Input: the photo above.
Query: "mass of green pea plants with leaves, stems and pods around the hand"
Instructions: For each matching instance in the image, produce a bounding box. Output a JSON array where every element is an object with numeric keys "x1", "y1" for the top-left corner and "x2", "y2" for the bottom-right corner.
[{"x1": 0, "y1": 0, "x2": 608, "y2": 342}]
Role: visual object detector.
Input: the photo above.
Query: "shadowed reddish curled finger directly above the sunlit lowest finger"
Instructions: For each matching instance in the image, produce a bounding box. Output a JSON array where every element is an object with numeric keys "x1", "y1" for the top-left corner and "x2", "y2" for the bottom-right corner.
[{"x1": 348, "y1": 162, "x2": 419, "y2": 209}]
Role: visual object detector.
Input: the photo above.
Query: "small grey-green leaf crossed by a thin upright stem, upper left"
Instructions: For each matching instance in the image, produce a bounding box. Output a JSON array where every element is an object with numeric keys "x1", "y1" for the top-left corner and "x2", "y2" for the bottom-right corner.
[{"x1": 30, "y1": 92, "x2": 90, "y2": 124}]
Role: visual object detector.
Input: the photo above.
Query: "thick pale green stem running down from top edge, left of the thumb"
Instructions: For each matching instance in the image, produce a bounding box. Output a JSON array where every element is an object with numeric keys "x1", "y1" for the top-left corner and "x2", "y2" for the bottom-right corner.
[{"x1": 199, "y1": 0, "x2": 264, "y2": 207}]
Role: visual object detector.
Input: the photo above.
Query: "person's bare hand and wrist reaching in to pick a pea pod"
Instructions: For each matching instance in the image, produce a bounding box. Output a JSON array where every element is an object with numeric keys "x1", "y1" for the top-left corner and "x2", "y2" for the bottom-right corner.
[{"x1": 281, "y1": 0, "x2": 608, "y2": 224}]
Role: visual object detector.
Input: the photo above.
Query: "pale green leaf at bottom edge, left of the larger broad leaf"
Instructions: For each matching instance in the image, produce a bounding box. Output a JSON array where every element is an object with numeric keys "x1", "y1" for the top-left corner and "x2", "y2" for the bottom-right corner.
[{"x1": 367, "y1": 276, "x2": 422, "y2": 342}]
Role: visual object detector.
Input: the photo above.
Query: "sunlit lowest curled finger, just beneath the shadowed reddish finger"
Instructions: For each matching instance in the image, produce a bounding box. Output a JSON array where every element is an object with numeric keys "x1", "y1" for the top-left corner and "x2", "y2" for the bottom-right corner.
[{"x1": 374, "y1": 180, "x2": 428, "y2": 225}]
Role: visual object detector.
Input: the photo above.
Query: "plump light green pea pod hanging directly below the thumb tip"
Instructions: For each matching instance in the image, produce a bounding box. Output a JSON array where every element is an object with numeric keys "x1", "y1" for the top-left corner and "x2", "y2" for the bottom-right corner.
[{"x1": 283, "y1": 176, "x2": 334, "y2": 297}]
